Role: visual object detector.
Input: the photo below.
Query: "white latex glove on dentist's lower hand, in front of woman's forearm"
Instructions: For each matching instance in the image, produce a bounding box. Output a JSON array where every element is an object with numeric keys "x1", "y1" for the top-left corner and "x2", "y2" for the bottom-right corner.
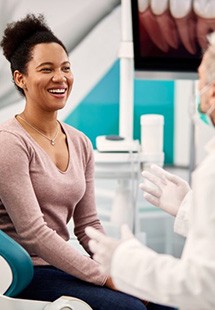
[{"x1": 85, "y1": 225, "x2": 134, "y2": 274}]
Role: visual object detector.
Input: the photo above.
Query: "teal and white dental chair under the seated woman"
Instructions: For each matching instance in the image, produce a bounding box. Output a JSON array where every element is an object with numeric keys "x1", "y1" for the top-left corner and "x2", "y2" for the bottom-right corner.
[{"x1": 0, "y1": 230, "x2": 92, "y2": 310}]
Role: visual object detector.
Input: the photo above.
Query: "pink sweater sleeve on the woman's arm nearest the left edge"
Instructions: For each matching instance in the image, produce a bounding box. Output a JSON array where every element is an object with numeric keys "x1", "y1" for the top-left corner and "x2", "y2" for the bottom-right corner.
[{"x1": 0, "y1": 131, "x2": 107, "y2": 285}]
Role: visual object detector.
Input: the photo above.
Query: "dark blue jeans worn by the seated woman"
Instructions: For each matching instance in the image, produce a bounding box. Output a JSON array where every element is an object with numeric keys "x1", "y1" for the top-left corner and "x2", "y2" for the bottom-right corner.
[{"x1": 17, "y1": 266, "x2": 175, "y2": 310}]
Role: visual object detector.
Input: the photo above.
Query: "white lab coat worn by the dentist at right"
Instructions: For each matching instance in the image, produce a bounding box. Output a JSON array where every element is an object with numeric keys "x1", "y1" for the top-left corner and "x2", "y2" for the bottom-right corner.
[{"x1": 111, "y1": 138, "x2": 215, "y2": 310}]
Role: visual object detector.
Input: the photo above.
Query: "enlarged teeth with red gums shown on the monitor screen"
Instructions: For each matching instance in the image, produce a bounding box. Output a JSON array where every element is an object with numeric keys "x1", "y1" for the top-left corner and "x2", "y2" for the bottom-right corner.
[{"x1": 138, "y1": 0, "x2": 215, "y2": 54}]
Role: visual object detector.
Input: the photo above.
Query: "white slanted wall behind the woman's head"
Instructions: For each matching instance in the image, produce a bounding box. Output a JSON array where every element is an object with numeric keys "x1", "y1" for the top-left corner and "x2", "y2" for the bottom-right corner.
[{"x1": 0, "y1": 0, "x2": 120, "y2": 123}]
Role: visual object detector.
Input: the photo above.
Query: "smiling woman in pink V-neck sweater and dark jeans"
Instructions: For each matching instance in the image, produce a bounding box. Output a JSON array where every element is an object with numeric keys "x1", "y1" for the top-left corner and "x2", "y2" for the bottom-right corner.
[{"x1": 0, "y1": 15, "x2": 146, "y2": 310}]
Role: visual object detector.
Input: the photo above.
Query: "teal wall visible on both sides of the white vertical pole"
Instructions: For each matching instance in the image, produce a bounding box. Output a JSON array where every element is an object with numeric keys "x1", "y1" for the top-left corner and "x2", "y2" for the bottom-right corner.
[{"x1": 65, "y1": 61, "x2": 174, "y2": 164}]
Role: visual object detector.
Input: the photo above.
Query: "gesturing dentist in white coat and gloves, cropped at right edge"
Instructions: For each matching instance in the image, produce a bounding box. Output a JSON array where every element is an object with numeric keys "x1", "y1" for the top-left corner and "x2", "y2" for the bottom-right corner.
[{"x1": 86, "y1": 33, "x2": 215, "y2": 310}]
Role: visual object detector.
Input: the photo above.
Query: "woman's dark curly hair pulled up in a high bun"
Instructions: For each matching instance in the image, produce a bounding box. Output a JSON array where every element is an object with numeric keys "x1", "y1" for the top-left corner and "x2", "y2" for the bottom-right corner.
[{"x1": 1, "y1": 14, "x2": 68, "y2": 95}]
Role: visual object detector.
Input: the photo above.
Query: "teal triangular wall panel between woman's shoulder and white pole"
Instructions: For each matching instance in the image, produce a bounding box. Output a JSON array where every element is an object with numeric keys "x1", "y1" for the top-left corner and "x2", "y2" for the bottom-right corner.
[{"x1": 65, "y1": 61, "x2": 119, "y2": 147}]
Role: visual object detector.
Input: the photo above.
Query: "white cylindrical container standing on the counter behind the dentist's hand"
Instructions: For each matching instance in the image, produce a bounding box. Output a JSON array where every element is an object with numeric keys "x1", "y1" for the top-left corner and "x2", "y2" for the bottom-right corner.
[{"x1": 140, "y1": 114, "x2": 164, "y2": 154}]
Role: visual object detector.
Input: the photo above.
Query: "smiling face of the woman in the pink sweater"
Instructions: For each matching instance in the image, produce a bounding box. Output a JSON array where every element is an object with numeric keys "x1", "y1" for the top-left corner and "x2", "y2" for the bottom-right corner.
[{"x1": 20, "y1": 43, "x2": 73, "y2": 111}]
